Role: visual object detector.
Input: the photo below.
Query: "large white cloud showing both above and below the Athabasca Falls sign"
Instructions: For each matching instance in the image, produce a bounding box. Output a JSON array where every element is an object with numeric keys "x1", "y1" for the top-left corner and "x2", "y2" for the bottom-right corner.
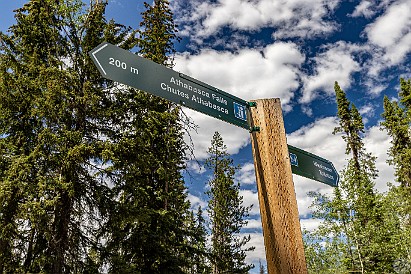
[{"x1": 175, "y1": 43, "x2": 304, "y2": 160}]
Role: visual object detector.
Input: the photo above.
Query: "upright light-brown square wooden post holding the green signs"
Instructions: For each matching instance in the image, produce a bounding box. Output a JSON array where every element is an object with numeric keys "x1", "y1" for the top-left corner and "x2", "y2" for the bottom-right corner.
[{"x1": 250, "y1": 99, "x2": 307, "y2": 274}]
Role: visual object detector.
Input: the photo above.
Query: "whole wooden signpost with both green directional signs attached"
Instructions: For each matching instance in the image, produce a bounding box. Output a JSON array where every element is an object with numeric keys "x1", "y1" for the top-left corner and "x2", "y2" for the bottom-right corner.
[{"x1": 90, "y1": 43, "x2": 339, "y2": 274}]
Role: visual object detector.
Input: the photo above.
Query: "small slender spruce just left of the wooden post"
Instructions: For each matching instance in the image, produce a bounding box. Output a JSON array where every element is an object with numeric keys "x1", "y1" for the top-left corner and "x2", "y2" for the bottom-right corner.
[{"x1": 206, "y1": 132, "x2": 254, "y2": 274}]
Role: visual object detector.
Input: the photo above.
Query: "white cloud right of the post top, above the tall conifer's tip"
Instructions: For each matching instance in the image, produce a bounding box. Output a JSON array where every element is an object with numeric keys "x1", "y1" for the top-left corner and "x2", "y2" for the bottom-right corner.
[{"x1": 300, "y1": 41, "x2": 361, "y2": 103}]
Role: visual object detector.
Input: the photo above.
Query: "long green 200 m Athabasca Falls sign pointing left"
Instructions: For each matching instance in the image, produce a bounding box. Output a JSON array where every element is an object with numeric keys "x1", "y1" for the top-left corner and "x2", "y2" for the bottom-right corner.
[{"x1": 89, "y1": 43, "x2": 249, "y2": 129}]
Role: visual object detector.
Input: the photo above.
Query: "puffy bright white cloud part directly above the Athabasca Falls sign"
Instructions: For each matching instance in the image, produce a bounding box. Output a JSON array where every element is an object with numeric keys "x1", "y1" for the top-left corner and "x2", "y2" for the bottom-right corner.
[{"x1": 175, "y1": 42, "x2": 304, "y2": 104}]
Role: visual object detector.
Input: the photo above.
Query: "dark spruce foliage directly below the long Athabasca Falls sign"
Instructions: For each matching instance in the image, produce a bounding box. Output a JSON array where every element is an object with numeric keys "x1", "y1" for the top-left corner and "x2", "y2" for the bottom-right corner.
[{"x1": 105, "y1": 96, "x2": 194, "y2": 273}]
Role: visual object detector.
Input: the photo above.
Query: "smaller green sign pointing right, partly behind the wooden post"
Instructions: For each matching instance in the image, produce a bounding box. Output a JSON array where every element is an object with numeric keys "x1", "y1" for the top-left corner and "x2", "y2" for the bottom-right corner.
[{"x1": 288, "y1": 145, "x2": 340, "y2": 187}]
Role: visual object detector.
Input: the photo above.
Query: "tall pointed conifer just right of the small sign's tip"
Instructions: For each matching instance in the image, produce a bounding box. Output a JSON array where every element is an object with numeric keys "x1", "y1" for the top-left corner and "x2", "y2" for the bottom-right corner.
[{"x1": 333, "y1": 82, "x2": 393, "y2": 272}]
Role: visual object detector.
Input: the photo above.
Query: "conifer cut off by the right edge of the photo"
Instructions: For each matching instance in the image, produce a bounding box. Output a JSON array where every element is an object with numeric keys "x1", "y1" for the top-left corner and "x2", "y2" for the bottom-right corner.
[{"x1": 381, "y1": 78, "x2": 411, "y2": 273}]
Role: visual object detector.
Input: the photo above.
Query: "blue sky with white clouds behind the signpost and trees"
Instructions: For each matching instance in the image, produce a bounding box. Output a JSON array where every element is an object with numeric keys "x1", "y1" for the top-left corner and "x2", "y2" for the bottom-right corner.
[{"x1": 0, "y1": 0, "x2": 411, "y2": 271}]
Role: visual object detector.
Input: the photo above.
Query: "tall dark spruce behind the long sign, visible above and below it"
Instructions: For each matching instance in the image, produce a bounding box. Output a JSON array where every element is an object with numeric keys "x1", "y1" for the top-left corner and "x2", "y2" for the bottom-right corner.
[{"x1": 103, "y1": 1, "x2": 193, "y2": 273}]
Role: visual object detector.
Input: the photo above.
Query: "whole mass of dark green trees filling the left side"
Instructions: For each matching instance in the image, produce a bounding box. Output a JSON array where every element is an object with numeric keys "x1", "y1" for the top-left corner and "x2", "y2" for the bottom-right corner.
[{"x1": 0, "y1": 0, "x2": 194, "y2": 274}]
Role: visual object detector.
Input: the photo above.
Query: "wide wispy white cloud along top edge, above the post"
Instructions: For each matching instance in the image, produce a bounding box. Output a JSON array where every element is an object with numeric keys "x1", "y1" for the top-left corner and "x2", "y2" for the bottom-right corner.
[{"x1": 174, "y1": 0, "x2": 340, "y2": 43}]
